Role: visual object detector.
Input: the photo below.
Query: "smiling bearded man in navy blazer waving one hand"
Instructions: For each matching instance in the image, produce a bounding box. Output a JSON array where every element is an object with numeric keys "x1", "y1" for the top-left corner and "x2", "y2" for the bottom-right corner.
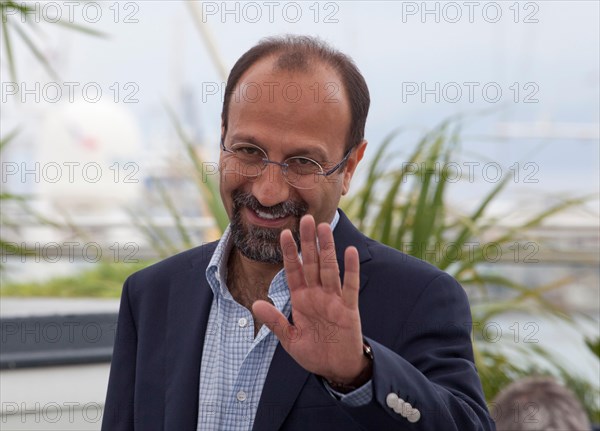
[{"x1": 103, "y1": 37, "x2": 494, "y2": 431}]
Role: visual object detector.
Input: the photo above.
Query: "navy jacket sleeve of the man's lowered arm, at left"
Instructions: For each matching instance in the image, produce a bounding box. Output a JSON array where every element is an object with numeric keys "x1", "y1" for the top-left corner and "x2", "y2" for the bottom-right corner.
[{"x1": 102, "y1": 279, "x2": 137, "y2": 431}]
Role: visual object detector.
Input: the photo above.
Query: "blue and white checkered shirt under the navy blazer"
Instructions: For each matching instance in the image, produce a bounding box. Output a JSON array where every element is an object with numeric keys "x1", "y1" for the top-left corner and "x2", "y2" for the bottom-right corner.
[{"x1": 197, "y1": 212, "x2": 373, "y2": 431}]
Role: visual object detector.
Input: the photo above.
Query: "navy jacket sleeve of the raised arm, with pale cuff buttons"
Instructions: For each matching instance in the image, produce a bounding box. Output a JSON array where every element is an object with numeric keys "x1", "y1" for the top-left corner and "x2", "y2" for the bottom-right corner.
[{"x1": 340, "y1": 274, "x2": 495, "y2": 431}]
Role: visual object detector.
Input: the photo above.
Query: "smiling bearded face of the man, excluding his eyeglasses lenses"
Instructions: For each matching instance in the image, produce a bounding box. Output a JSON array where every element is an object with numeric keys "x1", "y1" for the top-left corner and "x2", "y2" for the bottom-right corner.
[{"x1": 220, "y1": 58, "x2": 366, "y2": 263}]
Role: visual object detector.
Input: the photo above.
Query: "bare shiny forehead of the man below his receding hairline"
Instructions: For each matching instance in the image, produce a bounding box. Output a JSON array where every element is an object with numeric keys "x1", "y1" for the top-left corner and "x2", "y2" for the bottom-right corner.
[{"x1": 228, "y1": 56, "x2": 351, "y2": 154}]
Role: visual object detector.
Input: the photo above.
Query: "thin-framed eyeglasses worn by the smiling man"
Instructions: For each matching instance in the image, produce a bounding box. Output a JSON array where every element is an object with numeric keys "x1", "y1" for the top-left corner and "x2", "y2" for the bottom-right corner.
[{"x1": 221, "y1": 140, "x2": 354, "y2": 189}]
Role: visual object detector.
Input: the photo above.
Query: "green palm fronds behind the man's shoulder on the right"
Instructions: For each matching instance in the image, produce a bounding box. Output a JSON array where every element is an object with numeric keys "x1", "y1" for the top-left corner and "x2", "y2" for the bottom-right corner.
[{"x1": 342, "y1": 118, "x2": 600, "y2": 417}]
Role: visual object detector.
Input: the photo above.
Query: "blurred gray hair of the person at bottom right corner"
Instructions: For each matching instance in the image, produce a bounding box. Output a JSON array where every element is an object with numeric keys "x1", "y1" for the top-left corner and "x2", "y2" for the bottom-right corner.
[{"x1": 490, "y1": 377, "x2": 591, "y2": 431}]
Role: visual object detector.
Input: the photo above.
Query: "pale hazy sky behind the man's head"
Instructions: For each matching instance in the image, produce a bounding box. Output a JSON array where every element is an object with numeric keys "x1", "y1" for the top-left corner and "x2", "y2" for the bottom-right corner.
[{"x1": 1, "y1": 1, "x2": 600, "y2": 216}]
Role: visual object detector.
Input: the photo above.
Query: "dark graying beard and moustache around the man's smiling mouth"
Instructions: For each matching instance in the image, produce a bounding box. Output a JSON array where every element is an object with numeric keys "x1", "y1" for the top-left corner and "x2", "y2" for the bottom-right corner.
[{"x1": 231, "y1": 191, "x2": 308, "y2": 264}]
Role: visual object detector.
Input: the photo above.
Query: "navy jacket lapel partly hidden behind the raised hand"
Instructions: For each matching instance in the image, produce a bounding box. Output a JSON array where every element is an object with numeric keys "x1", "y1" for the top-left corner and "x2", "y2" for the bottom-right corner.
[{"x1": 253, "y1": 210, "x2": 371, "y2": 430}]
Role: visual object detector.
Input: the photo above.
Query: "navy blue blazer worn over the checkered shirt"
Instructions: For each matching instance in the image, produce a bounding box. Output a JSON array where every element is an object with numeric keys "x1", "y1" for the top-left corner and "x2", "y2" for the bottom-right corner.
[{"x1": 102, "y1": 211, "x2": 495, "y2": 431}]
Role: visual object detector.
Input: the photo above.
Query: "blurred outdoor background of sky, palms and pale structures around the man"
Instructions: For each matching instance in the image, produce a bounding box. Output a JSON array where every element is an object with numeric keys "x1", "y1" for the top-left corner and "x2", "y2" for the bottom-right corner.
[{"x1": 0, "y1": 1, "x2": 600, "y2": 429}]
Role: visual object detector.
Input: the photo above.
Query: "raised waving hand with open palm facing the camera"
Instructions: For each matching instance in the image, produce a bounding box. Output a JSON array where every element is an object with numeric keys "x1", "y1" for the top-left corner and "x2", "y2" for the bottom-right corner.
[{"x1": 252, "y1": 215, "x2": 370, "y2": 384}]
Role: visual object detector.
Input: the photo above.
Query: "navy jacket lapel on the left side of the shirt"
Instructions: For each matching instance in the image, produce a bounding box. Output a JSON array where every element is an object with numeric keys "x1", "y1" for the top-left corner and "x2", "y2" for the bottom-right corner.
[{"x1": 164, "y1": 244, "x2": 216, "y2": 430}]
